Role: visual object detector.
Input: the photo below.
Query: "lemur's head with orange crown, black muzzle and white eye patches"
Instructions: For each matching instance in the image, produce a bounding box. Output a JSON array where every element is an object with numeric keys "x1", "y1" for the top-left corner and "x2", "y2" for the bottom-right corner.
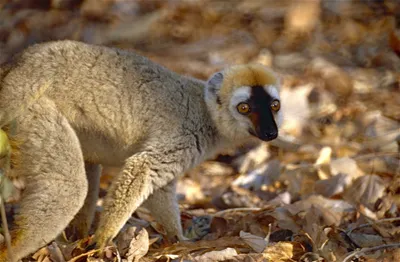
[{"x1": 205, "y1": 64, "x2": 282, "y2": 141}]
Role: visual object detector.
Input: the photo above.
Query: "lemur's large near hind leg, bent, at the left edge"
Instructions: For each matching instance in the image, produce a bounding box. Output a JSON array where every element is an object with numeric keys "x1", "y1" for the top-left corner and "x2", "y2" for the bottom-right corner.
[{"x1": 0, "y1": 98, "x2": 87, "y2": 262}]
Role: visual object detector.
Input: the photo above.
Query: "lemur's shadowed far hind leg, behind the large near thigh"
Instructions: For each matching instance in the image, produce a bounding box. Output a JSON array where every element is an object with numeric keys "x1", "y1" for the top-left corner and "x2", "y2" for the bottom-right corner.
[{"x1": 70, "y1": 162, "x2": 101, "y2": 240}]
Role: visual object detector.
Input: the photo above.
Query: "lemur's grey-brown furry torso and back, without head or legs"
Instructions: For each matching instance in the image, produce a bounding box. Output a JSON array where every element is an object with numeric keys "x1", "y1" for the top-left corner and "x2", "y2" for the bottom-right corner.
[{"x1": 0, "y1": 42, "x2": 216, "y2": 165}]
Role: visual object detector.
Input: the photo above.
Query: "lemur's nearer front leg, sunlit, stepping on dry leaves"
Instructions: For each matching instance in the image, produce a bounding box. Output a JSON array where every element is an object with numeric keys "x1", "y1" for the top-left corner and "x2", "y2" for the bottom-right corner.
[{"x1": 94, "y1": 147, "x2": 189, "y2": 248}]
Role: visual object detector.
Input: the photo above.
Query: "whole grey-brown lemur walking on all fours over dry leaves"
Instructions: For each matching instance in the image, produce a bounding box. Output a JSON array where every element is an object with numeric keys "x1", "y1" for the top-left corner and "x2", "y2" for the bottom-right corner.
[{"x1": 0, "y1": 40, "x2": 281, "y2": 261}]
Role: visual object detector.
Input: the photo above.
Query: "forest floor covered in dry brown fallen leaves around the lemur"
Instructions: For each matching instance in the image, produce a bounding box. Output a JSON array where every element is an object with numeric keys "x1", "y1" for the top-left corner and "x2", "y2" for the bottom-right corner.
[{"x1": 0, "y1": 0, "x2": 400, "y2": 262}]
